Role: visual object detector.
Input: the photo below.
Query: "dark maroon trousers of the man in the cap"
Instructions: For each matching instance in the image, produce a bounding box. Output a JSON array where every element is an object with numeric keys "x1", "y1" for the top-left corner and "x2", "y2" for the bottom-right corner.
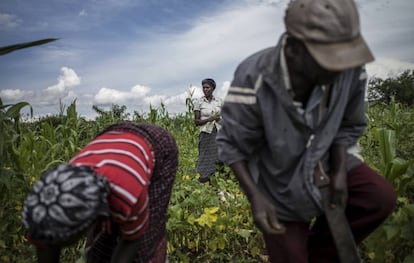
[{"x1": 264, "y1": 164, "x2": 396, "y2": 263}]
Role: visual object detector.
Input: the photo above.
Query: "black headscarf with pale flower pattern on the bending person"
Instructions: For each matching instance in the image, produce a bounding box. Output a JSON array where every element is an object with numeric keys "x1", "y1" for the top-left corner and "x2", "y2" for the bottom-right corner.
[{"x1": 23, "y1": 164, "x2": 110, "y2": 244}]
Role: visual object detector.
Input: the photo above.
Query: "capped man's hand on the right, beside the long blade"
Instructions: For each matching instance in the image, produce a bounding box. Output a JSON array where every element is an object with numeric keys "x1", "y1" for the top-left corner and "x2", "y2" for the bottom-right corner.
[{"x1": 330, "y1": 170, "x2": 348, "y2": 209}]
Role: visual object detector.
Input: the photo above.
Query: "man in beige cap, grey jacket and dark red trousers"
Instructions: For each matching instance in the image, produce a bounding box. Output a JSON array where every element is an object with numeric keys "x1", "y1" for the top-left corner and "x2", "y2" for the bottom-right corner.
[{"x1": 217, "y1": 0, "x2": 396, "y2": 263}]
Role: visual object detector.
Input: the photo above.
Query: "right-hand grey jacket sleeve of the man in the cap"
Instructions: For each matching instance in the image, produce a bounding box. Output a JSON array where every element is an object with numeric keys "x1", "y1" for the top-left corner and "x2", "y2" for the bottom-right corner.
[{"x1": 333, "y1": 68, "x2": 367, "y2": 146}]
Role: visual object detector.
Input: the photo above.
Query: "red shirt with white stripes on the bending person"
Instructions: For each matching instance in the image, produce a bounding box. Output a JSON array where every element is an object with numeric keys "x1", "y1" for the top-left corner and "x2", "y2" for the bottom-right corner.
[{"x1": 70, "y1": 131, "x2": 154, "y2": 240}]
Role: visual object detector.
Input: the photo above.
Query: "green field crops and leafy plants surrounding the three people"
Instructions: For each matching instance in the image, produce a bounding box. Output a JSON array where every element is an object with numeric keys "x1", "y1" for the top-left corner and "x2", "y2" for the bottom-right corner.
[{"x1": 0, "y1": 72, "x2": 414, "y2": 263}]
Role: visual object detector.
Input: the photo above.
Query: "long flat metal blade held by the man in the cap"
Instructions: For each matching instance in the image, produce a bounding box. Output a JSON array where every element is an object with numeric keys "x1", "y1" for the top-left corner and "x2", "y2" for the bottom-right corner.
[{"x1": 314, "y1": 163, "x2": 361, "y2": 263}]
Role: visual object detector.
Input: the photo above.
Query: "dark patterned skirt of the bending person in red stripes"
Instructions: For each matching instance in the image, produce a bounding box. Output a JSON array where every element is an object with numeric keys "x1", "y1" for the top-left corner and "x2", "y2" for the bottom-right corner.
[{"x1": 86, "y1": 122, "x2": 178, "y2": 263}]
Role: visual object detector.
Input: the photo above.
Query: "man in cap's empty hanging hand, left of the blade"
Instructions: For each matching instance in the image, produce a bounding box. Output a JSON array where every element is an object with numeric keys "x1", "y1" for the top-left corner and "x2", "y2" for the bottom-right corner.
[{"x1": 250, "y1": 192, "x2": 286, "y2": 234}]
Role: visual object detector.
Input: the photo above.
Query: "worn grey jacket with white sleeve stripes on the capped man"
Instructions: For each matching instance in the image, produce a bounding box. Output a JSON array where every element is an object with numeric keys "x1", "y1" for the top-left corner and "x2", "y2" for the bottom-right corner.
[{"x1": 217, "y1": 34, "x2": 366, "y2": 221}]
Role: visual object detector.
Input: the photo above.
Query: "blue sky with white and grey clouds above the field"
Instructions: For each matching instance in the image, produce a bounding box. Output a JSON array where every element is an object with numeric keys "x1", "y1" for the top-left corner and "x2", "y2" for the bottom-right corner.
[{"x1": 0, "y1": 0, "x2": 414, "y2": 118}]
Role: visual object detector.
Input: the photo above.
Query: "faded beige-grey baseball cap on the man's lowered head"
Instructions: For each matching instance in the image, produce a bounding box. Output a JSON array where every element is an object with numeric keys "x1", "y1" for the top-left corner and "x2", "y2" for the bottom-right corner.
[{"x1": 285, "y1": 0, "x2": 374, "y2": 71}]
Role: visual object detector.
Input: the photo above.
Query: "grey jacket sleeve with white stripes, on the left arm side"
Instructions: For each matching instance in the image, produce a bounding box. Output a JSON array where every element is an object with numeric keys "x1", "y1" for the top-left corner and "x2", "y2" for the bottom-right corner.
[{"x1": 216, "y1": 65, "x2": 264, "y2": 165}]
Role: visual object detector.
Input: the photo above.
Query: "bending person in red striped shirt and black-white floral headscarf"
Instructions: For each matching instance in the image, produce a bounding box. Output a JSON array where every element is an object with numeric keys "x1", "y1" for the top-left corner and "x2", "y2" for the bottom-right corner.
[{"x1": 23, "y1": 122, "x2": 178, "y2": 263}]
